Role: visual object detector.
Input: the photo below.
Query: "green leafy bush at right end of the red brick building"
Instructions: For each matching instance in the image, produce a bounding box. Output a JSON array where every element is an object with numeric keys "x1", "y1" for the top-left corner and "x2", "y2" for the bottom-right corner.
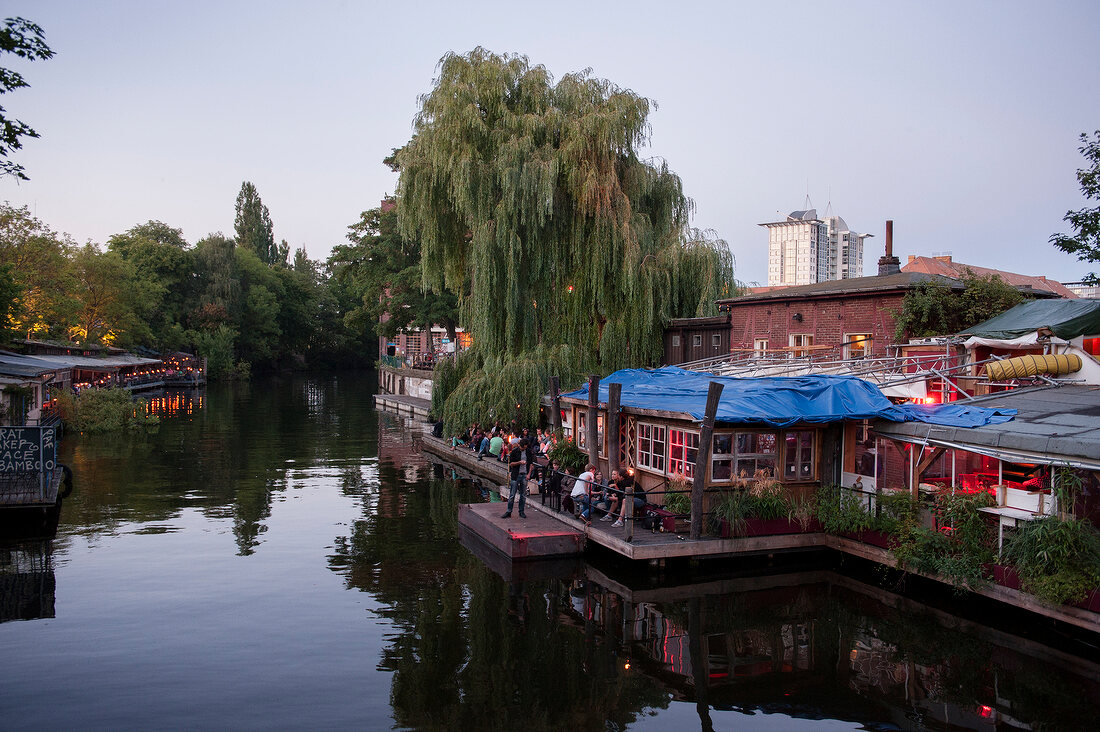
[{"x1": 894, "y1": 270, "x2": 1027, "y2": 340}]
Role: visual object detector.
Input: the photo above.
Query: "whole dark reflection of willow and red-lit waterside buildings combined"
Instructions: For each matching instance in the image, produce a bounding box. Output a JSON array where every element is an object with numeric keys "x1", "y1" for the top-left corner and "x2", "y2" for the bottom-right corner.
[{"x1": 330, "y1": 451, "x2": 1100, "y2": 730}]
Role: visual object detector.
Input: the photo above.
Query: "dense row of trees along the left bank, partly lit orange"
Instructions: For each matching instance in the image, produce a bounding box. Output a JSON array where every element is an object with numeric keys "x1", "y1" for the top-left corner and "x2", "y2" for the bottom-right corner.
[{"x1": 0, "y1": 182, "x2": 375, "y2": 379}]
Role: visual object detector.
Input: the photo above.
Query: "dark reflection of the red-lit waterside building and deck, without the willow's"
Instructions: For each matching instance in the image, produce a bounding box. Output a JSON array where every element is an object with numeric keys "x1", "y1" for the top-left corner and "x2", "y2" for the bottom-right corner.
[{"x1": 551, "y1": 566, "x2": 1100, "y2": 730}]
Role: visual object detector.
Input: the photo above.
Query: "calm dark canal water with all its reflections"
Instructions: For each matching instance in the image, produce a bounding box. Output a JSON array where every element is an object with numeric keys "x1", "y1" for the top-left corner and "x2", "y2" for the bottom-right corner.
[{"x1": 0, "y1": 374, "x2": 1100, "y2": 731}]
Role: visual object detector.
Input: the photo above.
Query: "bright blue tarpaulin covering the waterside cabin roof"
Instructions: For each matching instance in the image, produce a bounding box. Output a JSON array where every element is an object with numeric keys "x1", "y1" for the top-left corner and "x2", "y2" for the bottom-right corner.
[{"x1": 564, "y1": 367, "x2": 1015, "y2": 427}]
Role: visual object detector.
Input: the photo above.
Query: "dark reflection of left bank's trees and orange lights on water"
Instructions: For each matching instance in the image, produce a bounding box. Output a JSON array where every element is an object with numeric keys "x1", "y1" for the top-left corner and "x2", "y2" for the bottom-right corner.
[{"x1": 61, "y1": 375, "x2": 387, "y2": 556}]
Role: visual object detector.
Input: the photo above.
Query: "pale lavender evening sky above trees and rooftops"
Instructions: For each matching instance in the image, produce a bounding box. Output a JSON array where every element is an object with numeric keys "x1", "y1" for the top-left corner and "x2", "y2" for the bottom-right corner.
[{"x1": 0, "y1": 0, "x2": 1100, "y2": 283}]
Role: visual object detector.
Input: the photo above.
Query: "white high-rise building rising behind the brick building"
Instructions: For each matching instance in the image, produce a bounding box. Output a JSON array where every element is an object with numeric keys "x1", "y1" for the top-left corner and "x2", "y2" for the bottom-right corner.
[{"x1": 760, "y1": 208, "x2": 870, "y2": 287}]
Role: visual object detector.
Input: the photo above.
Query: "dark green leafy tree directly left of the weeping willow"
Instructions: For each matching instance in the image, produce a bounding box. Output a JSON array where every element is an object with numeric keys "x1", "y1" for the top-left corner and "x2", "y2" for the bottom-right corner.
[{"x1": 329, "y1": 199, "x2": 458, "y2": 340}]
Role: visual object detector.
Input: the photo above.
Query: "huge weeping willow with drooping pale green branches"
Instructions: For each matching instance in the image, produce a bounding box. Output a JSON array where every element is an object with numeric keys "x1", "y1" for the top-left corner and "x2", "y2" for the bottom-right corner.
[{"x1": 396, "y1": 48, "x2": 734, "y2": 424}]
